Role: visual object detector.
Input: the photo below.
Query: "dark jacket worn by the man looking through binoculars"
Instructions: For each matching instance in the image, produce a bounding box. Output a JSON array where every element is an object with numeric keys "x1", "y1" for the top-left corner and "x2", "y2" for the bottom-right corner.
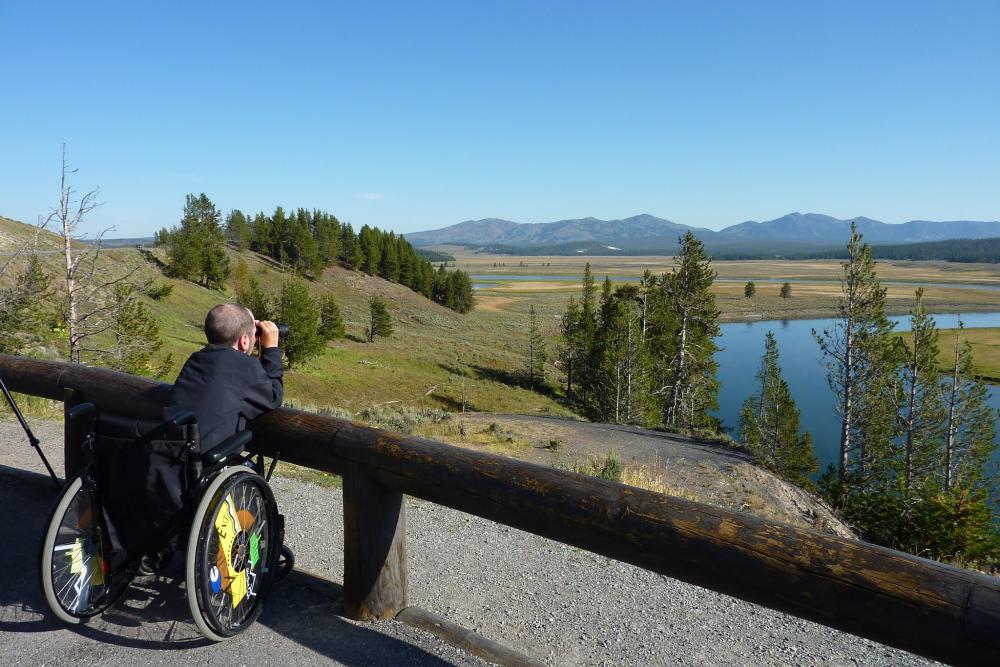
[{"x1": 163, "y1": 345, "x2": 284, "y2": 452}]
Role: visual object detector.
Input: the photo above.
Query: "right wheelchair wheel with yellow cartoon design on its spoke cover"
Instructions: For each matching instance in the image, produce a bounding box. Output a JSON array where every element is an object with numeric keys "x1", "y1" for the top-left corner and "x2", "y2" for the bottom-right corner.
[{"x1": 185, "y1": 466, "x2": 281, "y2": 641}]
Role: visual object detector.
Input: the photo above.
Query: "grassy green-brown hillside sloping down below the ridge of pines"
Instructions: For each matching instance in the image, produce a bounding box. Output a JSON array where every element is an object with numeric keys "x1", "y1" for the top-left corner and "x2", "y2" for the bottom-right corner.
[{"x1": 0, "y1": 219, "x2": 569, "y2": 414}]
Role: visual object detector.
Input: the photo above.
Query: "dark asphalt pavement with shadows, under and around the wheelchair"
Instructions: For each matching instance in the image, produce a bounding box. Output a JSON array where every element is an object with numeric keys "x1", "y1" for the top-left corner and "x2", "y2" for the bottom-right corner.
[{"x1": 0, "y1": 466, "x2": 464, "y2": 665}]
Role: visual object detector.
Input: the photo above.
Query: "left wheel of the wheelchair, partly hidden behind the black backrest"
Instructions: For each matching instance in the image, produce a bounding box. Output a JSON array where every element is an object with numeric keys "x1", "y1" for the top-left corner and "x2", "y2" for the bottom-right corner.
[{"x1": 39, "y1": 470, "x2": 131, "y2": 624}]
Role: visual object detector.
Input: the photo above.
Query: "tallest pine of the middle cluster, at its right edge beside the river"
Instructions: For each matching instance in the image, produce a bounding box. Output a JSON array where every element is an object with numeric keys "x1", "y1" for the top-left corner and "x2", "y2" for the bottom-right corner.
[{"x1": 653, "y1": 232, "x2": 719, "y2": 429}]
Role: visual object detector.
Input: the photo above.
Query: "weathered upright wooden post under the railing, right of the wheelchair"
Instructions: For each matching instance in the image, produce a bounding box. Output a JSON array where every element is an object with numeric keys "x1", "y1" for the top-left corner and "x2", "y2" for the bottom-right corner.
[{"x1": 343, "y1": 463, "x2": 406, "y2": 621}]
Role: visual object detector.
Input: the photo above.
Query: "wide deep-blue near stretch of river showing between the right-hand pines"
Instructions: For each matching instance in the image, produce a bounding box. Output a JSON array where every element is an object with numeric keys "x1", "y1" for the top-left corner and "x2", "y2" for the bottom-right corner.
[{"x1": 715, "y1": 312, "x2": 1000, "y2": 469}]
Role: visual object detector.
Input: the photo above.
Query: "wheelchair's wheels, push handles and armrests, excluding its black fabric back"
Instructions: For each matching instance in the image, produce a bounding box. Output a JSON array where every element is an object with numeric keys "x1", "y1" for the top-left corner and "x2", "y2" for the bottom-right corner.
[{"x1": 40, "y1": 403, "x2": 294, "y2": 641}]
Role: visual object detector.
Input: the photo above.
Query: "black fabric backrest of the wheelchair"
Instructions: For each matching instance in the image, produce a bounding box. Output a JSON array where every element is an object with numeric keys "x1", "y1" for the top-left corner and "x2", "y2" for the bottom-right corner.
[{"x1": 94, "y1": 413, "x2": 199, "y2": 553}]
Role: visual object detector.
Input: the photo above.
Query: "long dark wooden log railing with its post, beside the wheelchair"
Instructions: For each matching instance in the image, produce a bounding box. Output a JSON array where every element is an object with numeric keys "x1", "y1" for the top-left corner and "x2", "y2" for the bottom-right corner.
[{"x1": 0, "y1": 355, "x2": 1000, "y2": 665}]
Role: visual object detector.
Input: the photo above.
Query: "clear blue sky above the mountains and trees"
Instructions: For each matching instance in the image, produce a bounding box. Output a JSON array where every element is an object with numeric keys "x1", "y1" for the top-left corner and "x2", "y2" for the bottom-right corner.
[{"x1": 0, "y1": 1, "x2": 1000, "y2": 236}]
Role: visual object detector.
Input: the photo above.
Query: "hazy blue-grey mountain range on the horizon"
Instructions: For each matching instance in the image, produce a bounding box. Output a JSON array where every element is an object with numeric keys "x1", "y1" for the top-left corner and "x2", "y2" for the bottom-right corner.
[{"x1": 406, "y1": 213, "x2": 1000, "y2": 252}]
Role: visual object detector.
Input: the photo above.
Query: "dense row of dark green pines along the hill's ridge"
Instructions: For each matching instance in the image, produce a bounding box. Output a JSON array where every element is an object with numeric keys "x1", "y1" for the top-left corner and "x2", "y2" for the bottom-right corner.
[{"x1": 154, "y1": 193, "x2": 474, "y2": 313}]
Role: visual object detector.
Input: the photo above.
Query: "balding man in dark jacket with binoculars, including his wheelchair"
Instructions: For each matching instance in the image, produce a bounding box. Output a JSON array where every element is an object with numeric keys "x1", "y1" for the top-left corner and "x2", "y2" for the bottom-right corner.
[{"x1": 41, "y1": 304, "x2": 294, "y2": 641}]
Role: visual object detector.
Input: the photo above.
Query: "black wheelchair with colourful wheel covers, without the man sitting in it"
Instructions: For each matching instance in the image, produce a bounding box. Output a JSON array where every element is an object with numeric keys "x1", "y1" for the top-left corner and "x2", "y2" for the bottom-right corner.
[{"x1": 40, "y1": 403, "x2": 294, "y2": 641}]
